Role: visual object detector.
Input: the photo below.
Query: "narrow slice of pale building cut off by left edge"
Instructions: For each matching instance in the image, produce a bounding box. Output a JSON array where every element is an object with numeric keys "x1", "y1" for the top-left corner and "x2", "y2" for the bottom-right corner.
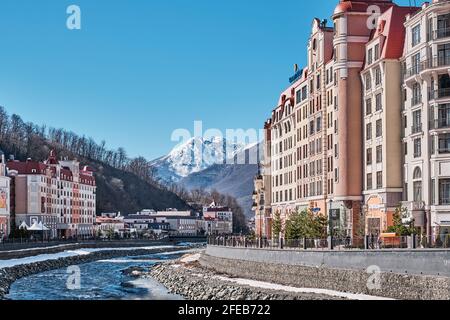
[{"x1": 0, "y1": 152, "x2": 11, "y2": 240}]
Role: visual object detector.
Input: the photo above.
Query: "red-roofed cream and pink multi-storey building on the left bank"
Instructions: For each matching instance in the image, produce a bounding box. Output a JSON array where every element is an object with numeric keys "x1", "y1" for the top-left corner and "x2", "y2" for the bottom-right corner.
[{"x1": 7, "y1": 151, "x2": 96, "y2": 238}]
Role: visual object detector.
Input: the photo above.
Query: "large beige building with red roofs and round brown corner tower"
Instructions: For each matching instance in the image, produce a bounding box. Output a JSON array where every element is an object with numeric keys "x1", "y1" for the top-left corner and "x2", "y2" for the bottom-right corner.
[{"x1": 256, "y1": 0, "x2": 436, "y2": 239}]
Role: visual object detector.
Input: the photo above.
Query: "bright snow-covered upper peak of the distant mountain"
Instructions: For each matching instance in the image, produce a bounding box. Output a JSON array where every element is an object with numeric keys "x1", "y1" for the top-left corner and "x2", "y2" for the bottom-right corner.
[{"x1": 151, "y1": 137, "x2": 251, "y2": 183}]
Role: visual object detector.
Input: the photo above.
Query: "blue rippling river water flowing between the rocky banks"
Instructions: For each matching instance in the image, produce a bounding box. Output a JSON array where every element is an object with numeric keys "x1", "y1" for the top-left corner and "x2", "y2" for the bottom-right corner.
[{"x1": 6, "y1": 251, "x2": 185, "y2": 300}]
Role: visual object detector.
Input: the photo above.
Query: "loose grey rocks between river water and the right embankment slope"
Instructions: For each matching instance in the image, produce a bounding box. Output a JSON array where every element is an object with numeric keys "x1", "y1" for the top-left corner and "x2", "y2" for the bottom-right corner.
[{"x1": 148, "y1": 255, "x2": 343, "y2": 300}]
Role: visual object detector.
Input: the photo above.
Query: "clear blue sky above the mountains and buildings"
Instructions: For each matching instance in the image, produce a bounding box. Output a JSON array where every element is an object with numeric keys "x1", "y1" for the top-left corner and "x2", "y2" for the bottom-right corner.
[{"x1": 0, "y1": 0, "x2": 421, "y2": 159}]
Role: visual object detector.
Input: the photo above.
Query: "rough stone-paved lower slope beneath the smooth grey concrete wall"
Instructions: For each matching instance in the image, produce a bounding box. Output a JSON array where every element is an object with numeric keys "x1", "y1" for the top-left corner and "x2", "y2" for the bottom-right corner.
[{"x1": 199, "y1": 253, "x2": 450, "y2": 300}]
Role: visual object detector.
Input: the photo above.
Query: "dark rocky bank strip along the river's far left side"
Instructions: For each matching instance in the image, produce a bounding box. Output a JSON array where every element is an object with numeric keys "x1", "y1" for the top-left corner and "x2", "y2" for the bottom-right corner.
[{"x1": 0, "y1": 247, "x2": 196, "y2": 300}]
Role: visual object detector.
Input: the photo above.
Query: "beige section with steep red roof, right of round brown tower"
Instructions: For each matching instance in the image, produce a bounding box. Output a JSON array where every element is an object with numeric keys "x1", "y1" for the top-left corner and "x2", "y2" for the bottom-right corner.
[{"x1": 361, "y1": 6, "x2": 418, "y2": 235}]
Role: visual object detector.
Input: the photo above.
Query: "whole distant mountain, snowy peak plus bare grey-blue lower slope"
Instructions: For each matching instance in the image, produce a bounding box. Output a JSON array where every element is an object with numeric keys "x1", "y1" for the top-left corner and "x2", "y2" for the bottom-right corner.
[{"x1": 151, "y1": 138, "x2": 263, "y2": 217}]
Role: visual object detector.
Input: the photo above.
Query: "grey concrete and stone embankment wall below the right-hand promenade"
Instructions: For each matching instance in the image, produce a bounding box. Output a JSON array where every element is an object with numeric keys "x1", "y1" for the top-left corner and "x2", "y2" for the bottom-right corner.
[{"x1": 200, "y1": 246, "x2": 450, "y2": 300}]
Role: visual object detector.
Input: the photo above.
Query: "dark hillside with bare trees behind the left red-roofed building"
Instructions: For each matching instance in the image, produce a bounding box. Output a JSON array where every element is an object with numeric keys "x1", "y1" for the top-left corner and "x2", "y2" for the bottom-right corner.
[{"x1": 0, "y1": 107, "x2": 189, "y2": 214}]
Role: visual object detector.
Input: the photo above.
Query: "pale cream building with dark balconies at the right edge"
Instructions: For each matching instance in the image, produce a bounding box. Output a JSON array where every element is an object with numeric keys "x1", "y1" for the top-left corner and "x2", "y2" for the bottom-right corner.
[{"x1": 402, "y1": 0, "x2": 450, "y2": 239}]
